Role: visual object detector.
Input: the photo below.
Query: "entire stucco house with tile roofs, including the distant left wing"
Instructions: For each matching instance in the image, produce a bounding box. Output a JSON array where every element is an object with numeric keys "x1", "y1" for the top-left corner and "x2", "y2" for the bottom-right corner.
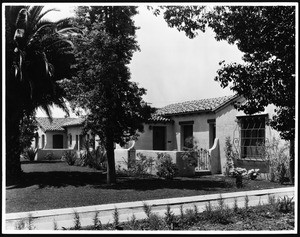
[{"x1": 34, "y1": 95, "x2": 284, "y2": 174}]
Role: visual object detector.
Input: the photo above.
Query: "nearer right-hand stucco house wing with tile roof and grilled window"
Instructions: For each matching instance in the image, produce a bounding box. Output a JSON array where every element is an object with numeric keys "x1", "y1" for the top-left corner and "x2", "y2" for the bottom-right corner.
[{"x1": 130, "y1": 95, "x2": 290, "y2": 173}]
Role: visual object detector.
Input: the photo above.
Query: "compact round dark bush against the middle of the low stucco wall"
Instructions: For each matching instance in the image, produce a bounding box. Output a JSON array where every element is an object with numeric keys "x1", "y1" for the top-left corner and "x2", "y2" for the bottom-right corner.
[{"x1": 156, "y1": 153, "x2": 178, "y2": 179}]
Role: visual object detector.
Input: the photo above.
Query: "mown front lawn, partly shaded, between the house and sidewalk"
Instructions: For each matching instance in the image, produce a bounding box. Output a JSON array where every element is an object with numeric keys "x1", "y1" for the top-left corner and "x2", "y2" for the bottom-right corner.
[{"x1": 5, "y1": 161, "x2": 291, "y2": 213}]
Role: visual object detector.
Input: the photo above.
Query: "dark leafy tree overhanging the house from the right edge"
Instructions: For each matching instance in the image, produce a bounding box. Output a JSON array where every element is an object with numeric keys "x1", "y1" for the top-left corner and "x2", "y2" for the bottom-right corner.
[{"x1": 152, "y1": 6, "x2": 296, "y2": 183}]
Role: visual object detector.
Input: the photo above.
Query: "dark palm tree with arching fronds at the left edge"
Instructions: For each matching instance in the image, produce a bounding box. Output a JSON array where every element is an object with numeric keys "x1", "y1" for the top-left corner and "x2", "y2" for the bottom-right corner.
[{"x1": 5, "y1": 6, "x2": 76, "y2": 181}]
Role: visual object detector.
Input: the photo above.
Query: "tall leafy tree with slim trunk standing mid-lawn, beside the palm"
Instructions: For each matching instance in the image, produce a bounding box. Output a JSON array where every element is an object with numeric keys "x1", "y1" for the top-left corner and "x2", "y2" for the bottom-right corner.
[{"x1": 65, "y1": 6, "x2": 150, "y2": 184}]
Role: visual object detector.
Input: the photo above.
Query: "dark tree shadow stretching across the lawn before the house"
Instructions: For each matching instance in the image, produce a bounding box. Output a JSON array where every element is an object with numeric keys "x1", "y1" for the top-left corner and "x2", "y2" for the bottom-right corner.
[{"x1": 7, "y1": 171, "x2": 232, "y2": 191}]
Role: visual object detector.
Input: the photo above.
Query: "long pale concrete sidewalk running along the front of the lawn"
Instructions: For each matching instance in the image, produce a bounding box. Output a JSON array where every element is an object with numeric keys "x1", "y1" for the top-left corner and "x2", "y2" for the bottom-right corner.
[{"x1": 5, "y1": 187, "x2": 295, "y2": 233}]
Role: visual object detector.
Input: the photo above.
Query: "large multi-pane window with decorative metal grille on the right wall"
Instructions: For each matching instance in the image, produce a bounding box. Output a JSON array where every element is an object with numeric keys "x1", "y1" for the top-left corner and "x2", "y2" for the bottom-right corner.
[{"x1": 240, "y1": 116, "x2": 266, "y2": 159}]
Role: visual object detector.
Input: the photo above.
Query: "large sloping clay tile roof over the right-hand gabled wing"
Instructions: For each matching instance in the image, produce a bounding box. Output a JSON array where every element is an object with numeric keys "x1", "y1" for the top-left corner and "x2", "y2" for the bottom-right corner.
[{"x1": 157, "y1": 95, "x2": 236, "y2": 116}]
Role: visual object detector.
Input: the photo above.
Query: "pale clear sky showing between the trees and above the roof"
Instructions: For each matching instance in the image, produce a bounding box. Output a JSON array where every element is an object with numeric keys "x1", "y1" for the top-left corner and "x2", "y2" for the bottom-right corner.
[{"x1": 37, "y1": 3, "x2": 242, "y2": 117}]
